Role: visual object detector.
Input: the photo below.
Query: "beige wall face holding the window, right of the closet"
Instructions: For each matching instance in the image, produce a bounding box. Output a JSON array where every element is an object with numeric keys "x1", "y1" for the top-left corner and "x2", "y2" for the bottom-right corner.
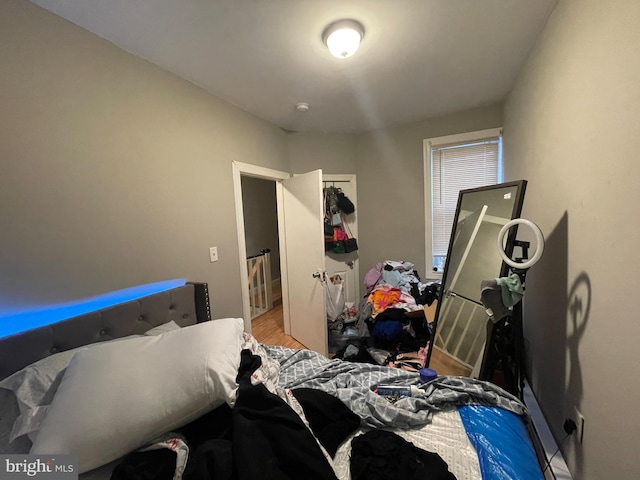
[{"x1": 356, "y1": 104, "x2": 502, "y2": 277}]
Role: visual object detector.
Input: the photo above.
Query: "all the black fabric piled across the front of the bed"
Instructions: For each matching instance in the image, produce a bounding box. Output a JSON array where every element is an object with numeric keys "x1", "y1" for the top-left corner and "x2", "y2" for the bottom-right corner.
[{"x1": 111, "y1": 350, "x2": 464, "y2": 480}]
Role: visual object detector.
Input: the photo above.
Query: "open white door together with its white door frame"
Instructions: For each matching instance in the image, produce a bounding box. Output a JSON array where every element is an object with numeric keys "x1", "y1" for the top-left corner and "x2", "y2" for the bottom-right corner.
[{"x1": 232, "y1": 162, "x2": 327, "y2": 354}]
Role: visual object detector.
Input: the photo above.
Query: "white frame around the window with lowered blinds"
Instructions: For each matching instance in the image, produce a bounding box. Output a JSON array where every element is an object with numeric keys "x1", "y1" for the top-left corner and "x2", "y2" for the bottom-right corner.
[{"x1": 422, "y1": 127, "x2": 504, "y2": 280}]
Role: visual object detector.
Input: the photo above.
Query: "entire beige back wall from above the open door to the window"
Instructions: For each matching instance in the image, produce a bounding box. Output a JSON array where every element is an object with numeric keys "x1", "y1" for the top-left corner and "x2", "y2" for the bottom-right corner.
[{"x1": 288, "y1": 104, "x2": 502, "y2": 281}]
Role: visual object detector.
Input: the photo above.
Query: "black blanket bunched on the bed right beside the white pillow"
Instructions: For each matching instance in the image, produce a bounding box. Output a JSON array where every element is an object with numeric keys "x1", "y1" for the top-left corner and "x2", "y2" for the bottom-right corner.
[{"x1": 111, "y1": 350, "x2": 360, "y2": 480}]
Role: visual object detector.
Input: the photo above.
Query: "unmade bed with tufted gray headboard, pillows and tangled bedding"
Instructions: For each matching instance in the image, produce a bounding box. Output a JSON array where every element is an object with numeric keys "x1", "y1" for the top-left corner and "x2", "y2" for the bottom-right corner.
[{"x1": 0, "y1": 283, "x2": 544, "y2": 480}]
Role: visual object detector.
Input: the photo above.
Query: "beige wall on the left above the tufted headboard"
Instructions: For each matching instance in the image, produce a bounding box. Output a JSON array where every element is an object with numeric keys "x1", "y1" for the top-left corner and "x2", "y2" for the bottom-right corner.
[{"x1": 0, "y1": 0, "x2": 288, "y2": 316}]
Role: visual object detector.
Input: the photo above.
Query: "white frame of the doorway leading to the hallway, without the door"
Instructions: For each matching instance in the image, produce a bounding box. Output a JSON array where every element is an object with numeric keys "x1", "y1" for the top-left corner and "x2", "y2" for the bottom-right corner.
[{"x1": 231, "y1": 160, "x2": 291, "y2": 335}]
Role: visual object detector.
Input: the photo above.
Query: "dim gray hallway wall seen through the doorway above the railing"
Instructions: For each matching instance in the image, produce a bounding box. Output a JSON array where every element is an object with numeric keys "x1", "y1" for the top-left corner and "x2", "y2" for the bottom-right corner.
[{"x1": 242, "y1": 176, "x2": 280, "y2": 280}]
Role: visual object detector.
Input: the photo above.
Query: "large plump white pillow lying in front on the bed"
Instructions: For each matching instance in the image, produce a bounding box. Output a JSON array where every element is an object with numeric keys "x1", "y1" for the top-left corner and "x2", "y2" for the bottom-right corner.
[{"x1": 31, "y1": 318, "x2": 243, "y2": 473}]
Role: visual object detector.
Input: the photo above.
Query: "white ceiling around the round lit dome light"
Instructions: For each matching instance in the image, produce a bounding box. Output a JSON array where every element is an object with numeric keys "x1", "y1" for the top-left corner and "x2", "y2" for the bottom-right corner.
[{"x1": 32, "y1": 0, "x2": 557, "y2": 132}]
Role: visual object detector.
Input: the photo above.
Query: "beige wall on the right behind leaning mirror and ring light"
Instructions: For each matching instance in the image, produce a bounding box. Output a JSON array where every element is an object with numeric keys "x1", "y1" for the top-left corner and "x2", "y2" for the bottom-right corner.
[{"x1": 504, "y1": 0, "x2": 640, "y2": 480}]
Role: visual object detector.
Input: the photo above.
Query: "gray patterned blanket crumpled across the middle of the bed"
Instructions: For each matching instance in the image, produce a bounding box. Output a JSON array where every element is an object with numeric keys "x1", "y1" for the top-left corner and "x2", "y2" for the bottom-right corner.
[{"x1": 264, "y1": 346, "x2": 528, "y2": 428}]
